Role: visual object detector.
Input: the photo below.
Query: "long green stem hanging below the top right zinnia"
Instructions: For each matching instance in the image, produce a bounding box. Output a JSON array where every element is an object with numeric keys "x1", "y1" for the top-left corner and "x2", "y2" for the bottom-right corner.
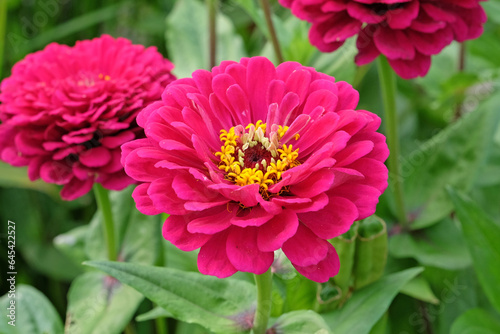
[{"x1": 378, "y1": 56, "x2": 408, "y2": 229}]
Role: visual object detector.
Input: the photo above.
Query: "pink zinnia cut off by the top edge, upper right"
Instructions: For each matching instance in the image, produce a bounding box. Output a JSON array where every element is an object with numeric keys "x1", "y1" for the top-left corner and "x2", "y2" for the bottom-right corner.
[{"x1": 279, "y1": 0, "x2": 486, "y2": 79}]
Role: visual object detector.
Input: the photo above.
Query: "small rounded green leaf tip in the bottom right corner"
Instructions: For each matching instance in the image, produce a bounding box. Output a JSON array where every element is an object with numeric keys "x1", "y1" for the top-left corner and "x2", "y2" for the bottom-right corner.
[{"x1": 450, "y1": 308, "x2": 500, "y2": 334}]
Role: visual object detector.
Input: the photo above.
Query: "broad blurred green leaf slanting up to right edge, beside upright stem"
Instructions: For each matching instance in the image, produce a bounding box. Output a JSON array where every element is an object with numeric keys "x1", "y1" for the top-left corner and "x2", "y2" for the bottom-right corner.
[{"x1": 400, "y1": 97, "x2": 500, "y2": 229}]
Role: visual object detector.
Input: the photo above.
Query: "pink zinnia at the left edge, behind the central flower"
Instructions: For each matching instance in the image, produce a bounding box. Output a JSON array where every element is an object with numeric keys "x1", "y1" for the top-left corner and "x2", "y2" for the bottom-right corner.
[{"x1": 0, "y1": 36, "x2": 175, "y2": 200}]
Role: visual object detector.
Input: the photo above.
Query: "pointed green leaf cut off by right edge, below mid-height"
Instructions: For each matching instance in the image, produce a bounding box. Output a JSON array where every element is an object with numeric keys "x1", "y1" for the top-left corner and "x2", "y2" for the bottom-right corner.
[{"x1": 448, "y1": 188, "x2": 500, "y2": 312}]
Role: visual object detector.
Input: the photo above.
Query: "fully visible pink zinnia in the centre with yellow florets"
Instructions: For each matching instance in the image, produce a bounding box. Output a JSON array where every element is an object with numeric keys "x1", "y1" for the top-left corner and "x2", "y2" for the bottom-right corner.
[{"x1": 122, "y1": 57, "x2": 389, "y2": 282}]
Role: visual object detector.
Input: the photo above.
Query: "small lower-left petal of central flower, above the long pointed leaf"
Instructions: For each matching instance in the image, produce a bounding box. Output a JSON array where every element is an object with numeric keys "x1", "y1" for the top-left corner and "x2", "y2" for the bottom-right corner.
[{"x1": 162, "y1": 216, "x2": 211, "y2": 252}]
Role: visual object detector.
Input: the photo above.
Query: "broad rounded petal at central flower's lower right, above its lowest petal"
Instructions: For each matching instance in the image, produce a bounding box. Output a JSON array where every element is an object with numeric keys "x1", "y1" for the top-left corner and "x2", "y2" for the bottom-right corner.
[{"x1": 299, "y1": 196, "x2": 358, "y2": 239}]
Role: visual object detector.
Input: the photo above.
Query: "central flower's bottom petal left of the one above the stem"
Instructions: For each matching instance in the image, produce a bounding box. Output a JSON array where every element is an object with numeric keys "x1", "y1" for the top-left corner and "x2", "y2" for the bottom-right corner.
[{"x1": 198, "y1": 232, "x2": 237, "y2": 278}]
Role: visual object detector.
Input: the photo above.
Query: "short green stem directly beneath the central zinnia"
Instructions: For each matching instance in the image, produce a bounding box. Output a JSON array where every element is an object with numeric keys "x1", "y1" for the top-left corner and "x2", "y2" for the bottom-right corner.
[{"x1": 253, "y1": 269, "x2": 273, "y2": 334}]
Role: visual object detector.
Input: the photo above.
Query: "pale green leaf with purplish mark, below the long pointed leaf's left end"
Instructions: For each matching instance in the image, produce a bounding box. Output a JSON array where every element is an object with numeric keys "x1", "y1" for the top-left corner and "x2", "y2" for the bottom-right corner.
[{"x1": 66, "y1": 272, "x2": 143, "y2": 334}]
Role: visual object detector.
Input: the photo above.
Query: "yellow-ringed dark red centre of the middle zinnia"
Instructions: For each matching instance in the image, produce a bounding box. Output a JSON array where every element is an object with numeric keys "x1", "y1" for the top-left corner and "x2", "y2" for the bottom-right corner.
[{"x1": 215, "y1": 120, "x2": 300, "y2": 199}]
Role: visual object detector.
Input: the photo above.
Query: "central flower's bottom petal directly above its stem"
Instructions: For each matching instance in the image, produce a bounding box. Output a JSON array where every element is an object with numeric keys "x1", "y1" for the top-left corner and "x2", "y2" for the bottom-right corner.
[{"x1": 226, "y1": 227, "x2": 274, "y2": 275}]
